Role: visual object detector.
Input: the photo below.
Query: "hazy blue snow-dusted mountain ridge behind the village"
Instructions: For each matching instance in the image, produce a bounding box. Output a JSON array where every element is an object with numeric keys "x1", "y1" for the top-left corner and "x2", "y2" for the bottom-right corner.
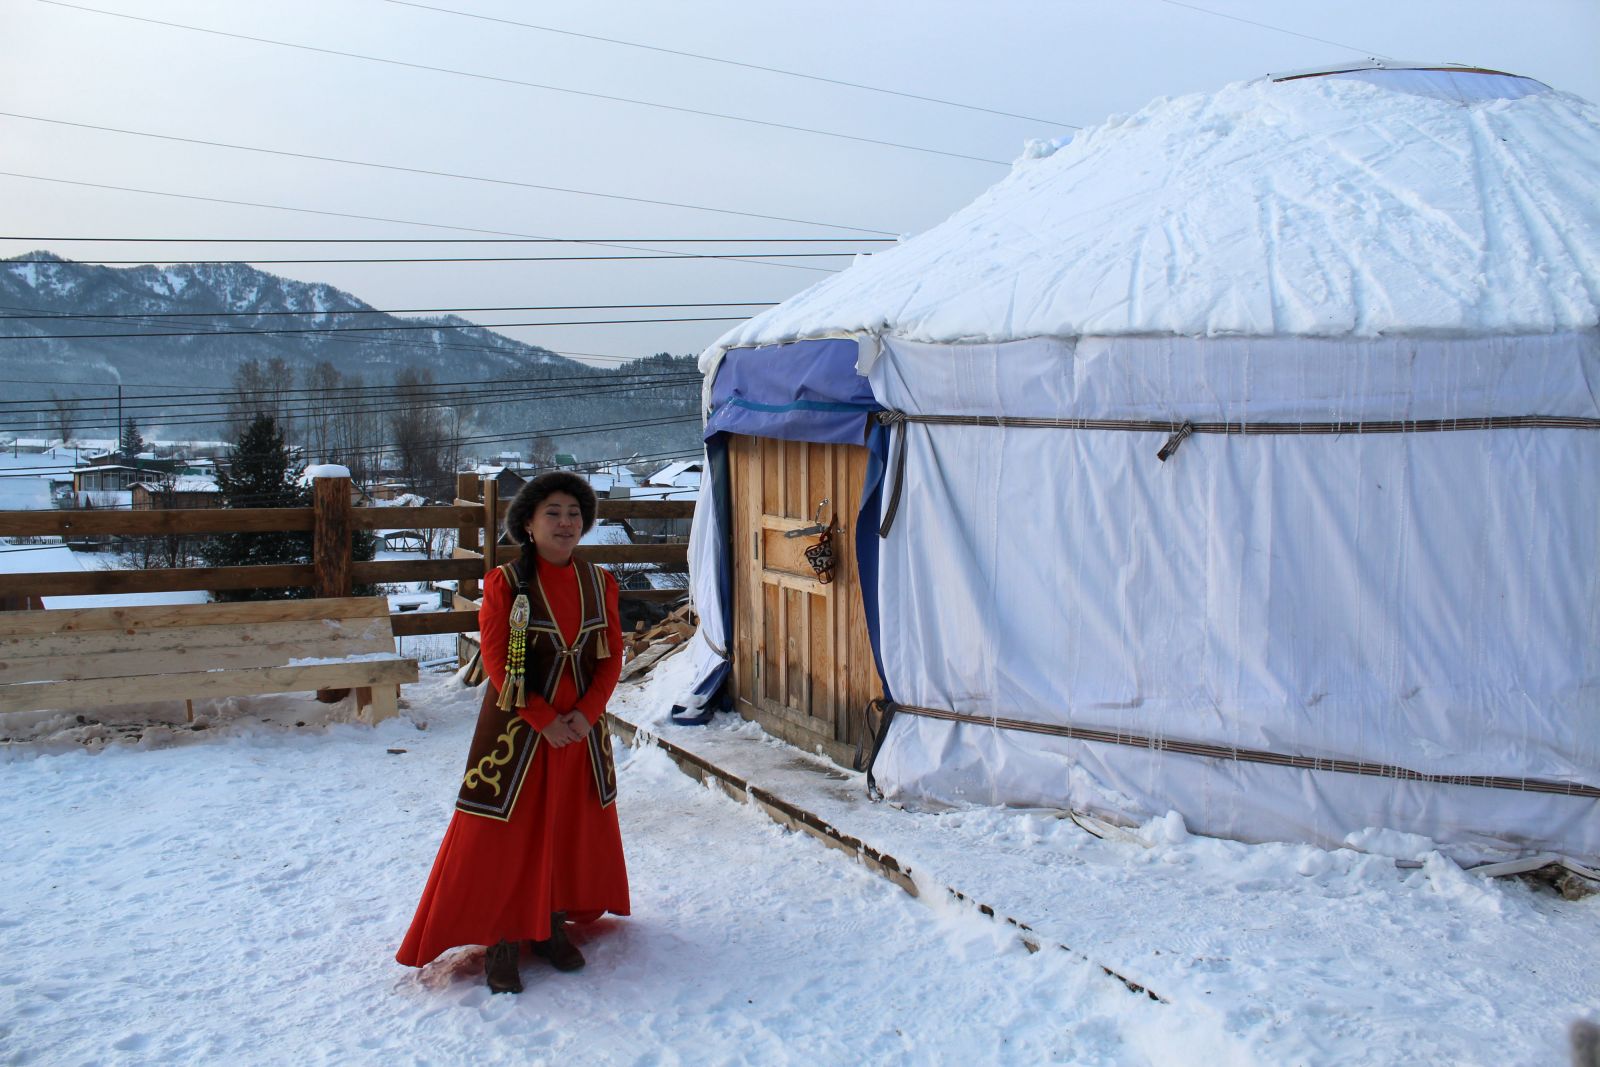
[{"x1": 0, "y1": 251, "x2": 699, "y2": 458}]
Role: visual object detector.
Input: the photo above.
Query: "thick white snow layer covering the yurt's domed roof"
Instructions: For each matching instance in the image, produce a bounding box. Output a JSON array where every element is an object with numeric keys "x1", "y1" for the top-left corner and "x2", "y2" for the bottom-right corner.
[{"x1": 712, "y1": 64, "x2": 1600, "y2": 352}]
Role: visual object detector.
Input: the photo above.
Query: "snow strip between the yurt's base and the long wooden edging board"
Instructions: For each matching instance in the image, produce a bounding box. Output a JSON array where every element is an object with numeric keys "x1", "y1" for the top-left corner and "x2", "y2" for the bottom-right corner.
[{"x1": 619, "y1": 661, "x2": 1600, "y2": 1065}]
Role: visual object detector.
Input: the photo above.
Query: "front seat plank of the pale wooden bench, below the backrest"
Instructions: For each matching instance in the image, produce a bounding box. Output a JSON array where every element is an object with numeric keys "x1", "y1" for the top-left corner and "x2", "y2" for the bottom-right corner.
[{"x1": 0, "y1": 659, "x2": 418, "y2": 712}]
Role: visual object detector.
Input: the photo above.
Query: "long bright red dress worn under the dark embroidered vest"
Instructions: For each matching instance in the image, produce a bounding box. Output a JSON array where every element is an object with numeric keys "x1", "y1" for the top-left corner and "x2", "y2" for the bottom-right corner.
[{"x1": 395, "y1": 558, "x2": 629, "y2": 966}]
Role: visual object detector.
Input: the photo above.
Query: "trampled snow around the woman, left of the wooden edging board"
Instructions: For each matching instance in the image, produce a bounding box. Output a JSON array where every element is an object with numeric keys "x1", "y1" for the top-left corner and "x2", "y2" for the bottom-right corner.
[{"x1": 0, "y1": 680, "x2": 1209, "y2": 1064}]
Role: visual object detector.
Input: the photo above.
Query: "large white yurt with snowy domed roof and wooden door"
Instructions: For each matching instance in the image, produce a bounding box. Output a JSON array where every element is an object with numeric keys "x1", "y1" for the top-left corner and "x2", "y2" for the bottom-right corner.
[{"x1": 691, "y1": 64, "x2": 1600, "y2": 862}]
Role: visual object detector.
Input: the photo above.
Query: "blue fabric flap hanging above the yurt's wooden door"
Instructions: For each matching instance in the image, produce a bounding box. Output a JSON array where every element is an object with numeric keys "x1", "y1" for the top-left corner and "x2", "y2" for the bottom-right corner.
[{"x1": 704, "y1": 338, "x2": 882, "y2": 445}]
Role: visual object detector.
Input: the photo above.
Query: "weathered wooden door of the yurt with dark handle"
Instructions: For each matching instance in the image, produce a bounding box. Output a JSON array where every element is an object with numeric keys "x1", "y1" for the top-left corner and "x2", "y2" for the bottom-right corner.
[{"x1": 728, "y1": 435, "x2": 883, "y2": 765}]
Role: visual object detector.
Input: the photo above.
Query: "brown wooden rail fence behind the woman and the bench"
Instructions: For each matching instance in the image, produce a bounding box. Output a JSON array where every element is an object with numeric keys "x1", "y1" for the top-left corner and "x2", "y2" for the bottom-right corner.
[{"x1": 0, "y1": 475, "x2": 694, "y2": 637}]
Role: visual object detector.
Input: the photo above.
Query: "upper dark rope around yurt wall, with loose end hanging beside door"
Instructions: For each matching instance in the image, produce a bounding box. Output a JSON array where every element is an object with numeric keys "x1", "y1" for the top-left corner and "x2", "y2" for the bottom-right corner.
[{"x1": 877, "y1": 411, "x2": 1600, "y2": 537}]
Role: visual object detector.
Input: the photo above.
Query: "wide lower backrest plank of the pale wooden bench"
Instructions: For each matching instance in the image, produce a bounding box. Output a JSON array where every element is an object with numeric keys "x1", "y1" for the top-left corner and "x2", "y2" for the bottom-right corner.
[{"x1": 0, "y1": 613, "x2": 394, "y2": 683}]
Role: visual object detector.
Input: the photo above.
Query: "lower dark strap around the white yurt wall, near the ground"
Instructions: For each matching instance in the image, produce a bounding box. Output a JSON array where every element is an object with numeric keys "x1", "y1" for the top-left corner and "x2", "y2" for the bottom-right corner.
[{"x1": 889, "y1": 704, "x2": 1600, "y2": 800}]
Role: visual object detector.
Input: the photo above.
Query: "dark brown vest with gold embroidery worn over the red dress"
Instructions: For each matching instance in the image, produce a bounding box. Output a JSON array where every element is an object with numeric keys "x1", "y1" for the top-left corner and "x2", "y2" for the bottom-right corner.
[{"x1": 456, "y1": 558, "x2": 616, "y2": 822}]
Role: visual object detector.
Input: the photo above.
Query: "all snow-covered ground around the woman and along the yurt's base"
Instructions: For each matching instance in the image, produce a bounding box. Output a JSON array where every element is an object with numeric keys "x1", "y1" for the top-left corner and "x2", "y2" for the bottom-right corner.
[{"x1": 0, "y1": 657, "x2": 1600, "y2": 1064}]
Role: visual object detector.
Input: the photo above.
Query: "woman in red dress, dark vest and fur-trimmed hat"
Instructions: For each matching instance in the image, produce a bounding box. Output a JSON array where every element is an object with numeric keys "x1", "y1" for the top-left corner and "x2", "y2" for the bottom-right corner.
[{"x1": 395, "y1": 470, "x2": 629, "y2": 993}]
